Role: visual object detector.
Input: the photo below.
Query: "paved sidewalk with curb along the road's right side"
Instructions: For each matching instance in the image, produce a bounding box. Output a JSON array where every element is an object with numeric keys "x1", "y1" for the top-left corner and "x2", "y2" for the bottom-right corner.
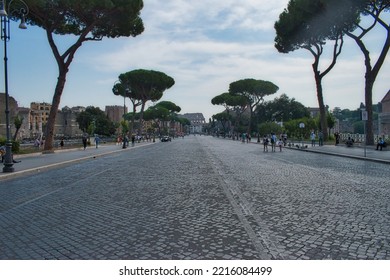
[{"x1": 291, "y1": 142, "x2": 390, "y2": 164}]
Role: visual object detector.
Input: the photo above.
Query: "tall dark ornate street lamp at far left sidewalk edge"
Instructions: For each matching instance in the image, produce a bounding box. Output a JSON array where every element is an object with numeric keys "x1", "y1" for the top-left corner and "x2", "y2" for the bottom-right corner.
[{"x1": 0, "y1": 0, "x2": 29, "y2": 172}]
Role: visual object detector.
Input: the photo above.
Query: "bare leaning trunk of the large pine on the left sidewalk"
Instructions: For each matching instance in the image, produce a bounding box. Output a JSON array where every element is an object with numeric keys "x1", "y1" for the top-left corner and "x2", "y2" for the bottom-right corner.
[{"x1": 44, "y1": 69, "x2": 67, "y2": 153}]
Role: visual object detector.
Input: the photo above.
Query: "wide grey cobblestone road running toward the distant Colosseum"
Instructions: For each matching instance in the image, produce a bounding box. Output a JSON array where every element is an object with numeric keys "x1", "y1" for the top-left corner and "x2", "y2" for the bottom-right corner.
[{"x1": 0, "y1": 136, "x2": 390, "y2": 260}]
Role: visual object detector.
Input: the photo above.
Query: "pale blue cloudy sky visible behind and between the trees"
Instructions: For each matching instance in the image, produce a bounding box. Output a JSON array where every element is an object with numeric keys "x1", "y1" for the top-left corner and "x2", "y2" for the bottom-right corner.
[{"x1": 0, "y1": 0, "x2": 390, "y2": 119}]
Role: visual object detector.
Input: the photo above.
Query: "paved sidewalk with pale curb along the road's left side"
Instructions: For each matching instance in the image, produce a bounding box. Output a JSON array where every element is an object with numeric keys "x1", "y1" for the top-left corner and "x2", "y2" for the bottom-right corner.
[{"x1": 0, "y1": 142, "x2": 155, "y2": 181}]
